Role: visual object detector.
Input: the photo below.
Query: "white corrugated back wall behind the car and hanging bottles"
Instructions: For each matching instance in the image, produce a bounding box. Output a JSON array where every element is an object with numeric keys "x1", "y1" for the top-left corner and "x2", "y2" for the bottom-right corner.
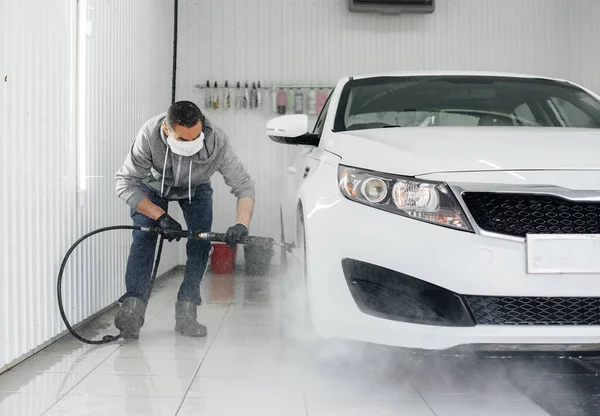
[{"x1": 177, "y1": 0, "x2": 600, "y2": 247}]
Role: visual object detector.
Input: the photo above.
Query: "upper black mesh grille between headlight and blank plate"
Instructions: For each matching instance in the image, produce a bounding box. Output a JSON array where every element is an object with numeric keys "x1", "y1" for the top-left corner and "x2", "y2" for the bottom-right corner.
[{"x1": 463, "y1": 192, "x2": 600, "y2": 237}]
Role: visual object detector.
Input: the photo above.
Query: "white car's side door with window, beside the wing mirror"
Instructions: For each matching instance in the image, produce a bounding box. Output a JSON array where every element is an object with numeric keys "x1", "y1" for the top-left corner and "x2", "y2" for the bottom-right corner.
[{"x1": 281, "y1": 91, "x2": 333, "y2": 241}]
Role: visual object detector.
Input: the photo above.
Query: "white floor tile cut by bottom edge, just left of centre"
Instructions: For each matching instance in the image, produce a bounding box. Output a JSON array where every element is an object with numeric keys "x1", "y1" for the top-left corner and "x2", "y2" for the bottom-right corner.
[{"x1": 177, "y1": 397, "x2": 306, "y2": 416}]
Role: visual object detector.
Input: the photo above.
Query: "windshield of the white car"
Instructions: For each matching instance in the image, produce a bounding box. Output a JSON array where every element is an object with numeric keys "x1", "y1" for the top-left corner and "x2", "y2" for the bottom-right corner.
[{"x1": 334, "y1": 76, "x2": 600, "y2": 131}]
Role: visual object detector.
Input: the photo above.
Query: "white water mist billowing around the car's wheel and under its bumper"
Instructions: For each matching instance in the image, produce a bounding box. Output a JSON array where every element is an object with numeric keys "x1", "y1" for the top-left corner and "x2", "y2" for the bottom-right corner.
[{"x1": 264, "y1": 244, "x2": 596, "y2": 414}]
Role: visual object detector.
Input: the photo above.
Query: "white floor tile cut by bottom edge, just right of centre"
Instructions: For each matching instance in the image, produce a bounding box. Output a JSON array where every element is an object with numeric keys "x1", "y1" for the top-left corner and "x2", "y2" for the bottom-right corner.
[{"x1": 307, "y1": 401, "x2": 434, "y2": 416}]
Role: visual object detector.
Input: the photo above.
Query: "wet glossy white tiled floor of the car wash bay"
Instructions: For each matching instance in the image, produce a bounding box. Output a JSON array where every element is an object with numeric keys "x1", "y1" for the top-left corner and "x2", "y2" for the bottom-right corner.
[{"x1": 0, "y1": 268, "x2": 568, "y2": 416}]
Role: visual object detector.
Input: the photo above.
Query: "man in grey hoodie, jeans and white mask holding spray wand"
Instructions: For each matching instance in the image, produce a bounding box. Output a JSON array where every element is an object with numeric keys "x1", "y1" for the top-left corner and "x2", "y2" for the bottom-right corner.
[{"x1": 115, "y1": 101, "x2": 254, "y2": 338}]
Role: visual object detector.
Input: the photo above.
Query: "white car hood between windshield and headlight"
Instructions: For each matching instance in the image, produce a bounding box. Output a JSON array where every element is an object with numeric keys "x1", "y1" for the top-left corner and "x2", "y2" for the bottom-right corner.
[{"x1": 324, "y1": 127, "x2": 600, "y2": 176}]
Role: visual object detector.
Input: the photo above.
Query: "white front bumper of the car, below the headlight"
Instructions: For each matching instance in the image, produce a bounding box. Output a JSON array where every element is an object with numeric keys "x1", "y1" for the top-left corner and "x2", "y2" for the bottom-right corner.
[{"x1": 305, "y1": 195, "x2": 600, "y2": 349}]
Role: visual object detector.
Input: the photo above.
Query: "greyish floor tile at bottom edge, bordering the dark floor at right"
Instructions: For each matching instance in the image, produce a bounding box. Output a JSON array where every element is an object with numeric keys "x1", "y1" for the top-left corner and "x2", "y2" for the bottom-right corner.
[{"x1": 428, "y1": 402, "x2": 549, "y2": 416}]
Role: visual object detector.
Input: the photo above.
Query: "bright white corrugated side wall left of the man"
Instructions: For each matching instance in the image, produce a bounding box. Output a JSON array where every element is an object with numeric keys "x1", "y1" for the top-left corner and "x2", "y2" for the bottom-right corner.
[{"x1": 0, "y1": 0, "x2": 177, "y2": 370}]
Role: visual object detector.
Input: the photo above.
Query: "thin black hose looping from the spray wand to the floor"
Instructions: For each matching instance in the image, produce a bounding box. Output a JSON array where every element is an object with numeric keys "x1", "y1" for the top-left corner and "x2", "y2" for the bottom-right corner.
[{"x1": 56, "y1": 225, "x2": 164, "y2": 345}]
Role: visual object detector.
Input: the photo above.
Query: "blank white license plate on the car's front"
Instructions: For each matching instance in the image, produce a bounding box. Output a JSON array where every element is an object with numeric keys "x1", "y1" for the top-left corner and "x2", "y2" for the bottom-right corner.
[{"x1": 526, "y1": 234, "x2": 600, "y2": 274}]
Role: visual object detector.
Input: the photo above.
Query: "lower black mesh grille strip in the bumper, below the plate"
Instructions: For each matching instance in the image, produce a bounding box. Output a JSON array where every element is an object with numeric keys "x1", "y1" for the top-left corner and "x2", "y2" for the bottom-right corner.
[{"x1": 465, "y1": 296, "x2": 600, "y2": 325}]
